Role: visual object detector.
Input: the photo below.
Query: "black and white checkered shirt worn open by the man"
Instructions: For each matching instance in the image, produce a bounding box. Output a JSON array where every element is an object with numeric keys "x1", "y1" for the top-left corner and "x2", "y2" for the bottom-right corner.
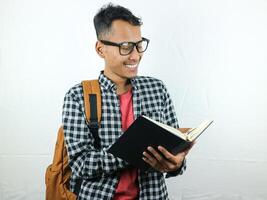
[{"x1": 63, "y1": 72, "x2": 186, "y2": 200}]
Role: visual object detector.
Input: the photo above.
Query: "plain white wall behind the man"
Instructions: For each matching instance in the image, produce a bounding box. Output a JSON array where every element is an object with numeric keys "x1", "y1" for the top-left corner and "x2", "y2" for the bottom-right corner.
[{"x1": 0, "y1": 0, "x2": 267, "y2": 200}]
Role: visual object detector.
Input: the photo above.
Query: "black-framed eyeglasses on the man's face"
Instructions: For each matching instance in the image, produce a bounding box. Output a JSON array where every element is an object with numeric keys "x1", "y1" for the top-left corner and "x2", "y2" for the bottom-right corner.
[{"x1": 100, "y1": 38, "x2": 149, "y2": 56}]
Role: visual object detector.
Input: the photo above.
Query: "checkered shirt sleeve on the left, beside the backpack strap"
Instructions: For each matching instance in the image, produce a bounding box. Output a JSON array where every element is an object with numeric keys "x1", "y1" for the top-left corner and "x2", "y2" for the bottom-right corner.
[{"x1": 62, "y1": 88, "x2": 128, "y2": 179}]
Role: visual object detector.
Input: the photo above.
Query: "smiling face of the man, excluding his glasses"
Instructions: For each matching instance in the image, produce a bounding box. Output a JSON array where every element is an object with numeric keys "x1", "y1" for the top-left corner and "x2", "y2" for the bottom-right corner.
[{"x1": 98, "y1": 20, "x2": 142, "y2": 82}]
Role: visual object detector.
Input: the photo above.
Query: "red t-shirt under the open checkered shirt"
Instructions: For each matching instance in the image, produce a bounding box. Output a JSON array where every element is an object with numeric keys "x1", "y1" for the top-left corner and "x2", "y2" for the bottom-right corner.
[{"x1": 113, "y1": 90, "x2": 139, "y2": 200}]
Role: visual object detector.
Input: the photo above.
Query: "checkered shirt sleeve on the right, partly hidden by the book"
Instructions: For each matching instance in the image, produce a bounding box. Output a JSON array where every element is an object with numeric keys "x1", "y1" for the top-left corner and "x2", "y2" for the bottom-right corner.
[{"x1": 163, "y1": 84, "x2": 186, "y2": 178}]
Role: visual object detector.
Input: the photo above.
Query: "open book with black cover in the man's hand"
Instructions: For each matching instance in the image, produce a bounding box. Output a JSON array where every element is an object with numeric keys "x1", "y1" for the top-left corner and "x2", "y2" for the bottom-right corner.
[{"x1": 108, "y1": 116, "x2": 213, "y2": 170}]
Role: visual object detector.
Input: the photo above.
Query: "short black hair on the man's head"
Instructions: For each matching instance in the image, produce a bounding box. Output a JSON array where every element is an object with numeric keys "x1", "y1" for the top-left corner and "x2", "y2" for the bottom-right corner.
[{"x1": 94, "y1": 3, "x2": 143, "y2": 39}]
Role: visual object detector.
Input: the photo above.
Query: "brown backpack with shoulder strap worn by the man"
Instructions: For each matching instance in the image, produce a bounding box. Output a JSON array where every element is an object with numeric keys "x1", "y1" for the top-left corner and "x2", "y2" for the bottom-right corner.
[{"x1": 45, "y1": 80, "x2": 101, "y2": 200}]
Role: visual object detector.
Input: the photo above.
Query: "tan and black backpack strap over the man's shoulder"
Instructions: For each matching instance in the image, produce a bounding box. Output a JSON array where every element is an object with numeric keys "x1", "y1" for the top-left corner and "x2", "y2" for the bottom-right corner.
[{"x1": 82, "y1": 80, "x2": 101, "y2": 149}]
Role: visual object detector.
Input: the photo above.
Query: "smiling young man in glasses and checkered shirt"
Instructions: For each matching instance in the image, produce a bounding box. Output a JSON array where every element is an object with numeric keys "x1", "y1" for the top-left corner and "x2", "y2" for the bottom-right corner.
[{"x1": 63, "y1": 4, "x2": 193, "y2": 200}]
